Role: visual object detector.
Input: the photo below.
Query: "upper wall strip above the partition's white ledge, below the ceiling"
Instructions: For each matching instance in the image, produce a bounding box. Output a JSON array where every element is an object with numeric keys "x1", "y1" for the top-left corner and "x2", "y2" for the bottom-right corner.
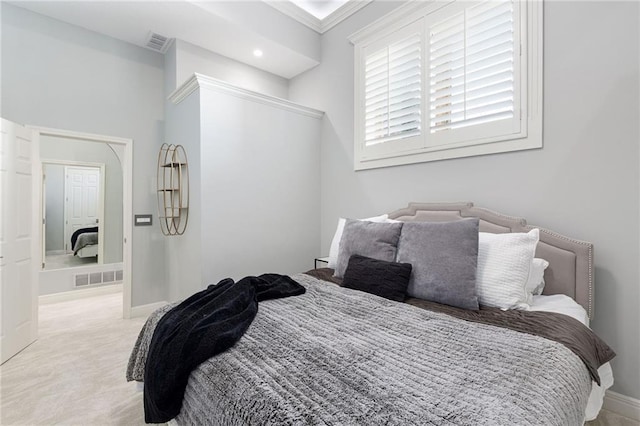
[{"x1": 165, "y1": 39, "x2": 289, "y2": 98}]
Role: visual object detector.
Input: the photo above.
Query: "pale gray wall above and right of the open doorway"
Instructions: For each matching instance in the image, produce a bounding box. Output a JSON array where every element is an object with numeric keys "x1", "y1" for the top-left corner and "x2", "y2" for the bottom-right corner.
[{"x1": 0, "y1": 2, "x2": 166, "y2": 306}]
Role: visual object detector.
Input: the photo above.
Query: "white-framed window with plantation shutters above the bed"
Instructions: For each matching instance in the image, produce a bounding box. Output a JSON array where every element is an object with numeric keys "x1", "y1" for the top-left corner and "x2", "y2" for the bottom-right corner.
[{"x1": 351, "y1": 0, "x2": 542, "y2": 170}]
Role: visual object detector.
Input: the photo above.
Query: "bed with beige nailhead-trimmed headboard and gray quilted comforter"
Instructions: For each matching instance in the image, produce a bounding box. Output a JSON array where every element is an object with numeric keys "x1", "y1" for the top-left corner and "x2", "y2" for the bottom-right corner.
[{"x1": 127, "y1": 203, "x2": 615, "y2": 425}]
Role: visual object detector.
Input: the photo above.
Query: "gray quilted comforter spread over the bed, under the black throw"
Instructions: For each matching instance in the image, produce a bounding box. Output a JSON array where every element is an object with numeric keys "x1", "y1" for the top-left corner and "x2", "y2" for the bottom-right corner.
[{"x1": 127, "y1": 274, "x2": 591, "y2": 426}]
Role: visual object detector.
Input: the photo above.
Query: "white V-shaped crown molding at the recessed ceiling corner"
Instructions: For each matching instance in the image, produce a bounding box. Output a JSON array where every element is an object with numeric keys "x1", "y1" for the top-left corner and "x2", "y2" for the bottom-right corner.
[{"x1": 265, "y1": 0, "x2": 373, "y2": 34}]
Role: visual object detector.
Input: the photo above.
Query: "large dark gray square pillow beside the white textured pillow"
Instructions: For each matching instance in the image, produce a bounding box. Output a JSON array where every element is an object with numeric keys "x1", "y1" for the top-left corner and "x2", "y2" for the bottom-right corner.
[{"x1": 397, "y1": 218, "x2": 479, "y2": 310}]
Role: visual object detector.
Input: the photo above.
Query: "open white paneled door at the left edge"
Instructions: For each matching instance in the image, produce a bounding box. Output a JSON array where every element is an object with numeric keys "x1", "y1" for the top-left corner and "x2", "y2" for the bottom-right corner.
[{"x1": 0, "y1": 119, "x2": 39, "y2": 363}]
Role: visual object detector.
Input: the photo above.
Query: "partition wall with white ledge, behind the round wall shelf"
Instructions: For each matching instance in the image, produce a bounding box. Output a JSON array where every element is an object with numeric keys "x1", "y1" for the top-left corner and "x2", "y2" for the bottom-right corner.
[{"x1": 166, "y1": 78, "x2": 321, "y2": 300}]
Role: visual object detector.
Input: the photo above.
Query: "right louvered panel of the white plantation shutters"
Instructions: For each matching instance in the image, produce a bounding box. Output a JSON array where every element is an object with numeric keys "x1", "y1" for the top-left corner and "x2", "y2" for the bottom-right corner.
[{"x1": 428, "y1": 1, "x2": 519, "y2": 137}]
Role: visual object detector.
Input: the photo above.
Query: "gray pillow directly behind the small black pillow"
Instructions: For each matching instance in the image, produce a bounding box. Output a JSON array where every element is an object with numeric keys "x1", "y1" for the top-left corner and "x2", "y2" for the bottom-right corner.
[{"x1": 334, "y1": 219, "x2": 402, "y2": 278}]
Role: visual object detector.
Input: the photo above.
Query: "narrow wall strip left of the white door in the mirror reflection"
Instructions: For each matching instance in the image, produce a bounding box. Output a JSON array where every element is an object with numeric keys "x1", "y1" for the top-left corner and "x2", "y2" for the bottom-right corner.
[{"x1": 43, "y1": 164, "x2": 64, "y2": 251}]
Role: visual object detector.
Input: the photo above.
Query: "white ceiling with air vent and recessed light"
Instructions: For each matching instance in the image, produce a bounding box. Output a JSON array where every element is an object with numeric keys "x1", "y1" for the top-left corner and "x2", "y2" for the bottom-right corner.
[{"x1": 9, "y1": 0, "x2": 371, "y2": 79}]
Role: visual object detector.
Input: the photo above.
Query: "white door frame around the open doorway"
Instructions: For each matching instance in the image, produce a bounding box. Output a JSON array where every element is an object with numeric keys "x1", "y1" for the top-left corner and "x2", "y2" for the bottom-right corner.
[{"x1": 27, "y1": 126, "x2": 133, "y2": 319}]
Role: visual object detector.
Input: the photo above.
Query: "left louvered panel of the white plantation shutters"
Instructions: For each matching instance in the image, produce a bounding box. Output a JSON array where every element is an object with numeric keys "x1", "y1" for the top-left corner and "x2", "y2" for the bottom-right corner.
[{"x1": 364, "y1": 34, "x2": 422, "y2": 146}]
